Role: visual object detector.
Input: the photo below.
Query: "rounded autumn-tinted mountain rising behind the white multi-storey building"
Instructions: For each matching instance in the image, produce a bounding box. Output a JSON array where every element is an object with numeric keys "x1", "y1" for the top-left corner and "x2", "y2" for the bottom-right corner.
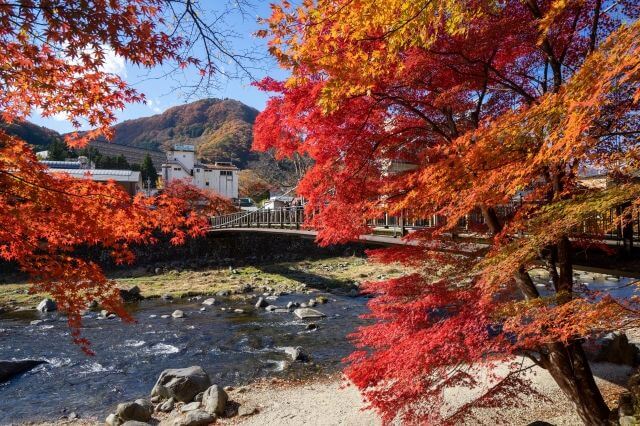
[{"x1": 104, "y1": 99, "x2": 258, "y2": 168}]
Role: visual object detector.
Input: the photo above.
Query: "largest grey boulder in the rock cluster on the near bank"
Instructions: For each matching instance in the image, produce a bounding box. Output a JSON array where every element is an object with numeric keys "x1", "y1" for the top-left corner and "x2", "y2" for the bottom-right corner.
[{"x1": 151, "y1": 366, "x2": 211, "y2": 402}]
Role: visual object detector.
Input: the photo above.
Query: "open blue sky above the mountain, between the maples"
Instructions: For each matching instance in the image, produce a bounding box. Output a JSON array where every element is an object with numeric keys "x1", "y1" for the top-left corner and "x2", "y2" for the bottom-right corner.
[{"x1": 30, "y1": 0, "x2": 286, "y2": 133}]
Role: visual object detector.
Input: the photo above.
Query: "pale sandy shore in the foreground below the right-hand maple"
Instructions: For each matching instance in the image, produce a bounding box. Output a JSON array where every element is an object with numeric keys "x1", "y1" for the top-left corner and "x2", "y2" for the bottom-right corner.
[{"x1": 222, "y1": 363, "x2": 632, "y2": 426}]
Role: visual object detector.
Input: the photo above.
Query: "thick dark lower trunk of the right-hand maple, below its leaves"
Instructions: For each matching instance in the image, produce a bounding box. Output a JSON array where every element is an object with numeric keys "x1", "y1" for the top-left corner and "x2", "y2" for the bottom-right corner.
[{"x1": 543, "y1": 341, "x2": 609, "y2": 426}]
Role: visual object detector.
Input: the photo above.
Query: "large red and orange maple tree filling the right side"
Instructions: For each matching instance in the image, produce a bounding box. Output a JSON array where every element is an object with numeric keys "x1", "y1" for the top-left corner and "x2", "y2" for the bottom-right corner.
[{"x1": 254, "y1": 0, "x2": 640, "y2": 424}]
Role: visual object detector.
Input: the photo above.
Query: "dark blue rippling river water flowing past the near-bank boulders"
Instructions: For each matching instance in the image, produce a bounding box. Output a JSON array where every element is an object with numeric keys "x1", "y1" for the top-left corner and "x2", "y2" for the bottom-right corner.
[{"x1": 0, "y1": 293, "x2": 366, "y2": 424}]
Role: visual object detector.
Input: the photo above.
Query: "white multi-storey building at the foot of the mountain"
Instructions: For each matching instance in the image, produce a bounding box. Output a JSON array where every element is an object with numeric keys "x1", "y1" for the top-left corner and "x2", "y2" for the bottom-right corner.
[{"x1": 162, "y1": 145, "x2": 238, "y2": 198}]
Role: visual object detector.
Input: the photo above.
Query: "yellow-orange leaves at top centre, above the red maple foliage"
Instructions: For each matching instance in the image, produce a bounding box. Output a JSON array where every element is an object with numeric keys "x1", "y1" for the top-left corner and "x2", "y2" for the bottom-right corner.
[{"x1": 268, "y1": 0, "x2": 496, "y2": 111}]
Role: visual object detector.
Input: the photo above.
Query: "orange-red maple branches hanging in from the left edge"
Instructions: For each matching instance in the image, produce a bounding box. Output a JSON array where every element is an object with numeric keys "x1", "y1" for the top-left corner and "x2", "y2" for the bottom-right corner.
[{"x1": 0, "y1": 0, "x2": 239, "y2": 352}]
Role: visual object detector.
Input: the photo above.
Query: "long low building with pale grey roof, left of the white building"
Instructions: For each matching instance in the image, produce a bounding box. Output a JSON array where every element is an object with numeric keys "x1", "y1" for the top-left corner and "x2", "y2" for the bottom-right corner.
[{"x1": 41, "y1": 157, "x2": 142, "y2": 196}]
